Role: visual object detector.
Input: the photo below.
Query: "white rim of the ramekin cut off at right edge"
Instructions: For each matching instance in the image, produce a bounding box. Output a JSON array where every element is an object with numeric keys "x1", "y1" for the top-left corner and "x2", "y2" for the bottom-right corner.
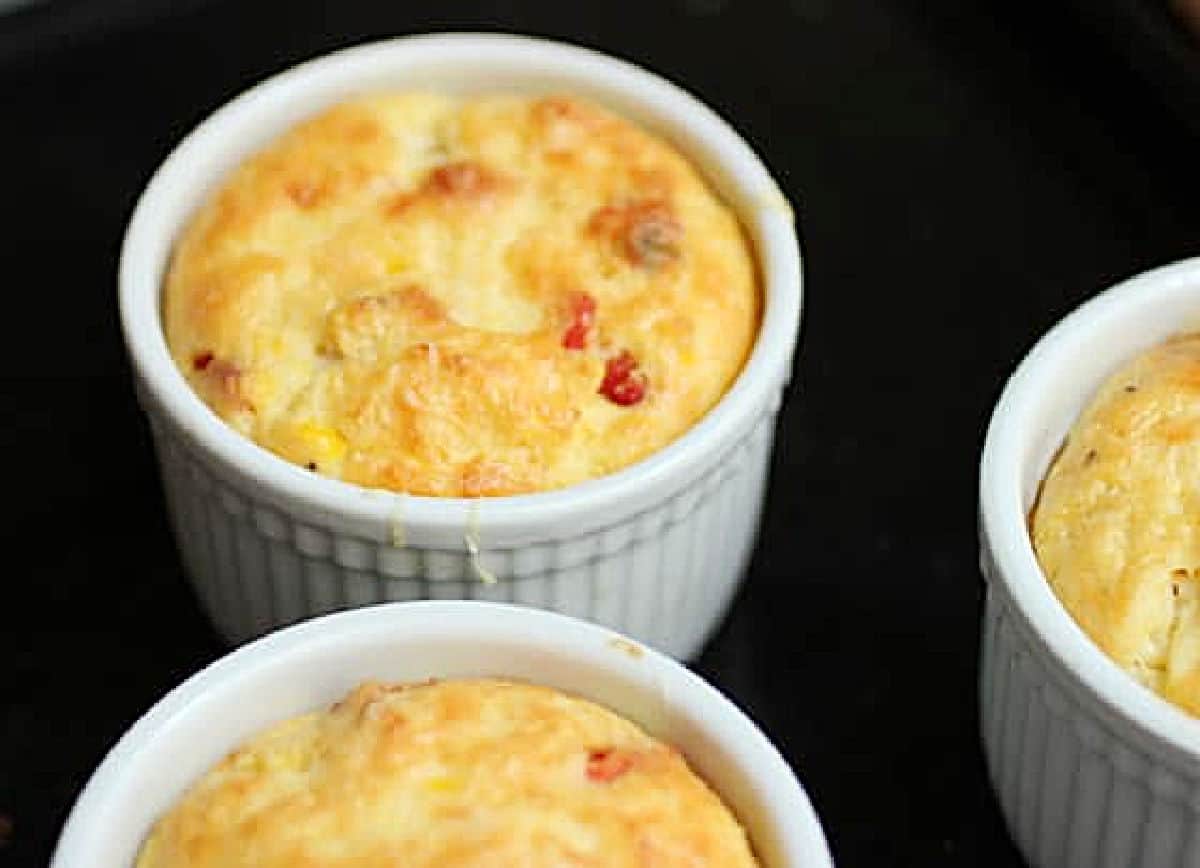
[{"x1": 979, "y1": 257, "x2": 1200, "y2": 764}]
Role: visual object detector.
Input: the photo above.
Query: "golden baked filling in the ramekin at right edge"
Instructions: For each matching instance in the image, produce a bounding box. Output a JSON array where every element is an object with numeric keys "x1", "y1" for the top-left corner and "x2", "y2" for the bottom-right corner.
[{"x1": 1032, "y1": 335, "x2": 1200, "y2": 714}]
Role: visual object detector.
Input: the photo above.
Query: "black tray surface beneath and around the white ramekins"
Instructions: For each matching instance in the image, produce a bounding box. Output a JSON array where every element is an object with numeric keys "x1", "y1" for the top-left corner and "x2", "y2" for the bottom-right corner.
[{"x1": 7, "y1": 0, "x2": 1200, "y2": 866}]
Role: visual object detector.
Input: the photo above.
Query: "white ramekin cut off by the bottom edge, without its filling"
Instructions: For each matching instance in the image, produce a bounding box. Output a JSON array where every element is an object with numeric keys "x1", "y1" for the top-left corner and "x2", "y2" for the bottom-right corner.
[{"x1": 52, "y1": 601, "x2": 833, "y2": 868}]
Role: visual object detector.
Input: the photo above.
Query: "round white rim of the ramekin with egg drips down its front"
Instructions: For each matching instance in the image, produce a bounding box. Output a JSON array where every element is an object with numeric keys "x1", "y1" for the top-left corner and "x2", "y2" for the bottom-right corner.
[{"x1": 119, "y1": 32, "x2": 803, "y2": 537}]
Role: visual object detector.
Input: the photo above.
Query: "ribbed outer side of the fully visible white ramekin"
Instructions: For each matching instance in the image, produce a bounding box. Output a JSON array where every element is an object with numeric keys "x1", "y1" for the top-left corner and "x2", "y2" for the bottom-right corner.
[{"x1": 142, "y1": 403, "x2": 778, "y2": 659}]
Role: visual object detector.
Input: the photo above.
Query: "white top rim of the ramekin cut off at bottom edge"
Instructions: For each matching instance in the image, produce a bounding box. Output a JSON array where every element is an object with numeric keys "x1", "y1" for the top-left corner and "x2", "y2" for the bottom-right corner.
[{"x1": 50, "y1": 600, "x2": 834, "y2": 868}]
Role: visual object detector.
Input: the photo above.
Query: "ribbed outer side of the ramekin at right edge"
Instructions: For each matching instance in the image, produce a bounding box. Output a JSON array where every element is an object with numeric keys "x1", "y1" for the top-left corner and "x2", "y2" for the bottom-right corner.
[{"x1": 979, "y1": 555, "x2": 1200, "y2": 868}]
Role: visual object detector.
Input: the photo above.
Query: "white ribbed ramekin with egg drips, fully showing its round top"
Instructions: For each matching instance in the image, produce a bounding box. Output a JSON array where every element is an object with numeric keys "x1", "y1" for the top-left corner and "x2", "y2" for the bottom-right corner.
[{"x1": 120, "y1": 34, "x2": 800, "y2": 658}]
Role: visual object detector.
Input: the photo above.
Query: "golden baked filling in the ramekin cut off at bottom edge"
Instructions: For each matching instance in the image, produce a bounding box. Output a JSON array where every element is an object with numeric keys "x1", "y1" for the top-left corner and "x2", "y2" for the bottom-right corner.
[{"x1": 137, "y1": 681, "x2": 755, "y2": 868}]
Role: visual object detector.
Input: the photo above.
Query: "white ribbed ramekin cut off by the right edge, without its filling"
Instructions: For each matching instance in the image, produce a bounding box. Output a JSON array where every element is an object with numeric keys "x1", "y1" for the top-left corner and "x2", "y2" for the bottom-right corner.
[{"x1": 979, "y1": 259, "x2": 1200, "y2": 868}]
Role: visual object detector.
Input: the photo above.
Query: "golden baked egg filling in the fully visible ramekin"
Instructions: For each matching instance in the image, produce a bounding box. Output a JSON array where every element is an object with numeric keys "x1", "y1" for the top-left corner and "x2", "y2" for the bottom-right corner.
[{"x1": 164, "y1": 94, "x2": 761, "y2": 497}]
